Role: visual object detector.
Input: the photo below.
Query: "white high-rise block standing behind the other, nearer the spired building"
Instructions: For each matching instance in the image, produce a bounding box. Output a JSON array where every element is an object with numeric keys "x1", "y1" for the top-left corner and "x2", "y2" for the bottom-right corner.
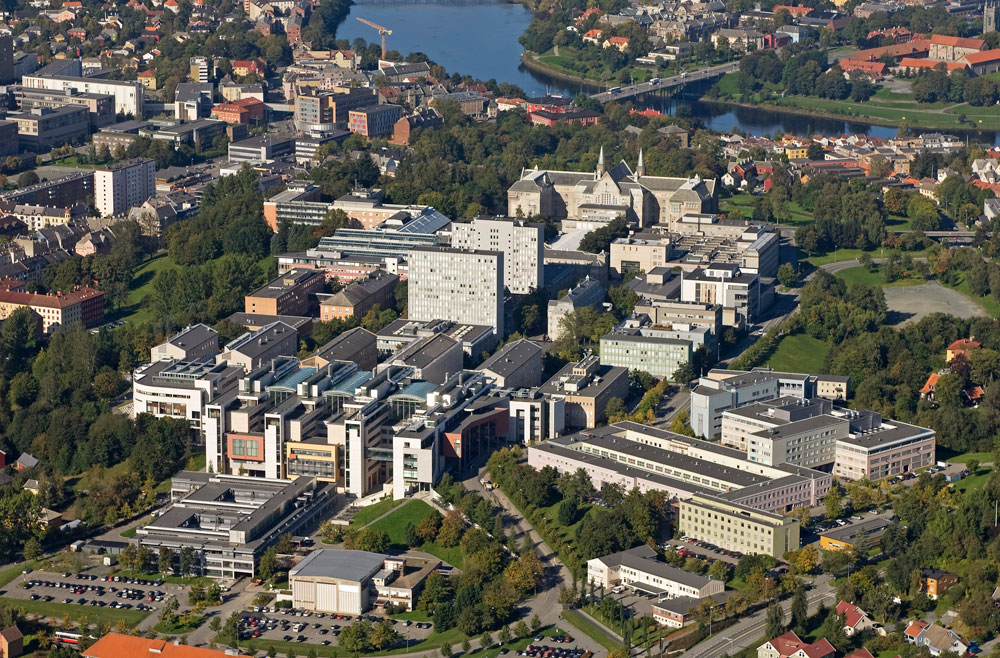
[{"x1": 451, "y1": 217, "x2": 545, "y2": 295}]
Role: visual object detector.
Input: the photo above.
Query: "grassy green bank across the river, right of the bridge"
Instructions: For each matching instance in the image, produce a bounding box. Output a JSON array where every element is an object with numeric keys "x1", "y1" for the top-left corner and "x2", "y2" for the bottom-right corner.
[{"x1": 701, "y1": 79, "x2": 1000, "y2": 133}]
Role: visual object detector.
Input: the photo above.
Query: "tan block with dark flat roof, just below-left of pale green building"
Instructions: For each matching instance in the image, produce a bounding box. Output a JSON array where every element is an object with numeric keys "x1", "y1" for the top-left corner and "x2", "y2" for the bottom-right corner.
[{"x1": 539, "y1": 355, "x2": 628, "y2": 428}]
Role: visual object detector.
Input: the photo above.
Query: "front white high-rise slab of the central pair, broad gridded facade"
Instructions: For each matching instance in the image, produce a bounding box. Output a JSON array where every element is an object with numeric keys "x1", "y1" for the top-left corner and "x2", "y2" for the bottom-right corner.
[{"x1": 407, "y1": 247, "x2": 504, "y2": 337}]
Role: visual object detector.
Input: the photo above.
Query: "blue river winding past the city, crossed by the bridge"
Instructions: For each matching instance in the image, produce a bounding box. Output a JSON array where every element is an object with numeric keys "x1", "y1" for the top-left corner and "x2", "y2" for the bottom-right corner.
[{"x1": 337, "y1": 0, "x2": 997, "y2": 144}]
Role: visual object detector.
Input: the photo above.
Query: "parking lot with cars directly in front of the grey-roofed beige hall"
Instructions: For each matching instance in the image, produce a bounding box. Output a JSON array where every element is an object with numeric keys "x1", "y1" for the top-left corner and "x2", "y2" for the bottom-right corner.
[{"x1": 240, "y1": 607, "x2": 433, "y2": 646}]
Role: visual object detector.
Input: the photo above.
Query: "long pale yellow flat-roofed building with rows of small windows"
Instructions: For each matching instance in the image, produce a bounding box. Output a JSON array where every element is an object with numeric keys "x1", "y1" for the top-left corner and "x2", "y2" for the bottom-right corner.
[{"x1": 677, "y1": 494, "x2": 799, "y2": 559}]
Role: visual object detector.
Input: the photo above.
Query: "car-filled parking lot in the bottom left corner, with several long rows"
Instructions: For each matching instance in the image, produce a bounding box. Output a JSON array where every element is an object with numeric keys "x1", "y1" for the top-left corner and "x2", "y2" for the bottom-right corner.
[{"x1": 0, "y1": 571, "x2": 173, "y2": 612}]
